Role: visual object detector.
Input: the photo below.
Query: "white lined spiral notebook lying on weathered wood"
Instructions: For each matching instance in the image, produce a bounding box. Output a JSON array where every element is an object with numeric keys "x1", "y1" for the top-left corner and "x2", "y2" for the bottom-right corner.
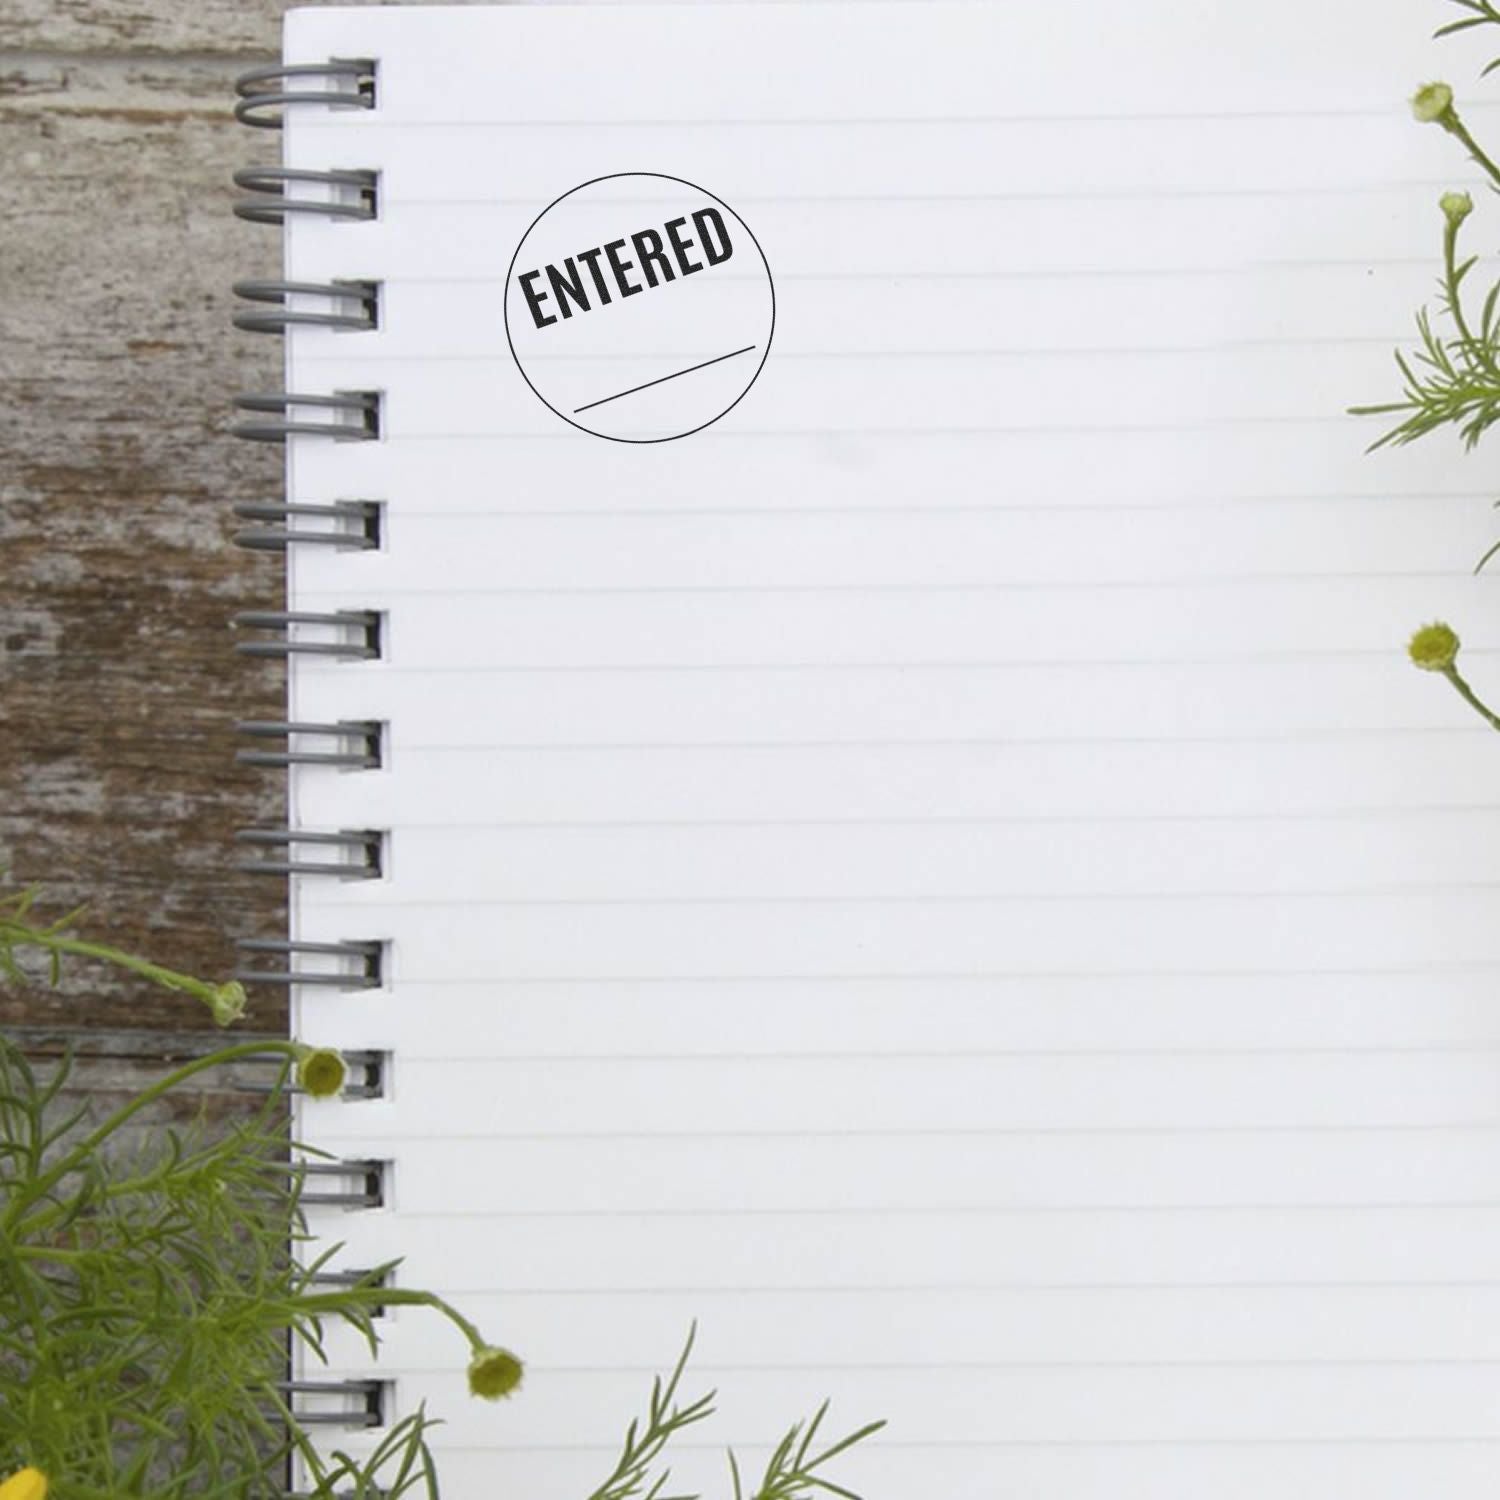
[{"x1": 225, "y1": 0, "x2": 1500, "y2": 1500}]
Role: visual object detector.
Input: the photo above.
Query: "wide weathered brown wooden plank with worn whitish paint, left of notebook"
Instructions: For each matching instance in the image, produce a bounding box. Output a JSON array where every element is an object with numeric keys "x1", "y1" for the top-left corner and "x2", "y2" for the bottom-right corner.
[{"x1": 0, "y1": 61, "x2": 285, "y2": 1031}]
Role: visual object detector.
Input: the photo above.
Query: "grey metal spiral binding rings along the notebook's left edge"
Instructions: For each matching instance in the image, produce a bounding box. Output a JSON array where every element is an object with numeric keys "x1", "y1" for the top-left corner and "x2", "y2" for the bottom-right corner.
[{"x1": 233, "y1": 57, "x2": 390, "y2": 1476}]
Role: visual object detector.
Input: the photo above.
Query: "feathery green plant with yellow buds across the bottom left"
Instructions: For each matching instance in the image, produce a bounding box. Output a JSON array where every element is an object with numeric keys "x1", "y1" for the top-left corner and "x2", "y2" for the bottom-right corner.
[{"x1": 0, "y1": 891, "x2": 885, "y2": 1500}]
